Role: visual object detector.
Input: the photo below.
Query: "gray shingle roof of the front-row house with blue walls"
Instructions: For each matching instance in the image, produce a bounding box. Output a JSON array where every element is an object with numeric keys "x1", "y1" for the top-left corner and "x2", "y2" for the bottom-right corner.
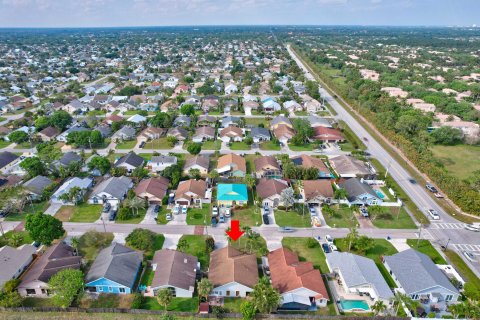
[{"x1": 85, "y1": 243, "x2": 143, "y2": 287}]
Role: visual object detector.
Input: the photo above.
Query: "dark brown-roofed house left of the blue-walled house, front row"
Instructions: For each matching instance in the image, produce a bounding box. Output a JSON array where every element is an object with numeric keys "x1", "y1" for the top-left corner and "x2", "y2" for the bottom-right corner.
[{"x1": 17, "y1": 242, "x2": 82, "y2": 298}]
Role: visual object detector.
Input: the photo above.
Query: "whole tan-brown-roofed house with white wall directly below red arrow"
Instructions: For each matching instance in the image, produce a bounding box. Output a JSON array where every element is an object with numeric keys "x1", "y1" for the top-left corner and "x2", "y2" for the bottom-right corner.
[{"x1": 208, "y1": 246, "x2": 258, "y2": 297}]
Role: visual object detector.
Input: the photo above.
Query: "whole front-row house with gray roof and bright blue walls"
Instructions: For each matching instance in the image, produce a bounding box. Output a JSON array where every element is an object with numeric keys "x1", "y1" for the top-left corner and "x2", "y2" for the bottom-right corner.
[{"x1": 85, "y1": 243, "x2": 143, "y2": 294}]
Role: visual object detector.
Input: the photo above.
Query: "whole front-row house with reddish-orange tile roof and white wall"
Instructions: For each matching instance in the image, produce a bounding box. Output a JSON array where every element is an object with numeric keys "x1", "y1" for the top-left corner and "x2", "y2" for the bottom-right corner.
[{"x1": 268, "y1": 248, "x2": 329, "y2": 310}]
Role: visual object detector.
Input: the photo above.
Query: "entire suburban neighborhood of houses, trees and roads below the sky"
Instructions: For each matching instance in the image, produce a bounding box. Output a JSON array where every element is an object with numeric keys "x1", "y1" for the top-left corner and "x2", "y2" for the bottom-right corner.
[{"x1": 0, "y1": 5, "x2": 480, "y2": 319}]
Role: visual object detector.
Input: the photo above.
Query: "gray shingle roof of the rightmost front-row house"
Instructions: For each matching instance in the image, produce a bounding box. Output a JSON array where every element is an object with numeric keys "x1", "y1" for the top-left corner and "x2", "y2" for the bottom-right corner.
[{"x1": 385, "y1": 249, "x2": 458, "y2": 294}]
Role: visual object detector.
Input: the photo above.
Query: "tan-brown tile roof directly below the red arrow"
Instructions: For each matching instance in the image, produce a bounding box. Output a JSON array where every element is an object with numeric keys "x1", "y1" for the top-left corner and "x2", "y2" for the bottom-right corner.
[{"x1": 208, "y1": 246, "x2": 258, "y2": 288}]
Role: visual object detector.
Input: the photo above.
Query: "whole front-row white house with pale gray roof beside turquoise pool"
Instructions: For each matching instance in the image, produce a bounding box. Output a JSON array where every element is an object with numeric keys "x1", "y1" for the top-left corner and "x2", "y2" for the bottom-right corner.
[{"x1": 326, "y1": 251, "x2": 393, "y2": 305}]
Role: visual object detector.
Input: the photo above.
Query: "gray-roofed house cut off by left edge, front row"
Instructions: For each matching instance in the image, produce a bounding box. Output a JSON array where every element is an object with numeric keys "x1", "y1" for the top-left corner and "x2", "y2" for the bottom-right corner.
[{"x1": 0, "y1": 244, "x2": 37, "y2": 288}]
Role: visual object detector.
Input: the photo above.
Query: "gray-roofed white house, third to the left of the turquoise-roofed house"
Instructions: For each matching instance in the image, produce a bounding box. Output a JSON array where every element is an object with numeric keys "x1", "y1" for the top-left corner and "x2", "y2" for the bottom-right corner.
[{"x1": 88, "y1": 176, "x2": 133, "y2": 208}]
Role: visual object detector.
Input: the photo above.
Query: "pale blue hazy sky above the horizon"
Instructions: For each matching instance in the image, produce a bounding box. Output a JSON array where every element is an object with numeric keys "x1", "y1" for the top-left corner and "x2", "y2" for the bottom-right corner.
[{"x1": 0, "y1": 0, "x2": 480, "y2": 28}]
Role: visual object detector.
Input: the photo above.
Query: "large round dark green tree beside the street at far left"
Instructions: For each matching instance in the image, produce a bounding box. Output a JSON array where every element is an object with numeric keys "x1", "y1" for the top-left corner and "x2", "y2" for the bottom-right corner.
[{"x1": 25, "y1": 212, "x2": 65, "y2": 246}]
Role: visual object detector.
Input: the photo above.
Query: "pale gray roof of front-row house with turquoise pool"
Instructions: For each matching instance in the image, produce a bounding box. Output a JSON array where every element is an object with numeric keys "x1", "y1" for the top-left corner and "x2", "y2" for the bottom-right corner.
[{"x1": 326, "y1": 251, "x2": 393, "y2": 299}]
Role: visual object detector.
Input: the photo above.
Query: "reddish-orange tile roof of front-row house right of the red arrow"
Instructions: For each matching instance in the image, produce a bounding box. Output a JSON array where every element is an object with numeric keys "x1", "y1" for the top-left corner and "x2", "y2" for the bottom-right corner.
[{"x1": 268, "y1": 248, "x2": 328, "y2": 299}]
